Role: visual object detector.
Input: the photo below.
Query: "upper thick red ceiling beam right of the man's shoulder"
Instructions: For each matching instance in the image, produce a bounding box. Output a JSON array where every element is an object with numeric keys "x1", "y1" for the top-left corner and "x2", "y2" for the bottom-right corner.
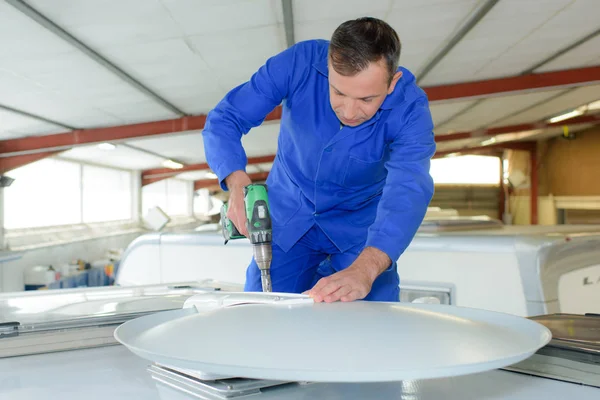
[{"x1": 423, "y1": 66, "x2": 600, "y2": 101}]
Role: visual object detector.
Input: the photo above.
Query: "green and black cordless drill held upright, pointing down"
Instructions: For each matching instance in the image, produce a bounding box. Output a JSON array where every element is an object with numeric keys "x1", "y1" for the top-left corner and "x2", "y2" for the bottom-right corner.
[{"x1": 221, "y1": 183, "x2": 272, "y2": 292}]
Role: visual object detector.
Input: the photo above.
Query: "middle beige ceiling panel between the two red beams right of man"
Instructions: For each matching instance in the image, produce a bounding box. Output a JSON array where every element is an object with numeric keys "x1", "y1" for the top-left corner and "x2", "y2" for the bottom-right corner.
[{"x1": 438, "y1": 90, "x2": 560, "y2": 132}]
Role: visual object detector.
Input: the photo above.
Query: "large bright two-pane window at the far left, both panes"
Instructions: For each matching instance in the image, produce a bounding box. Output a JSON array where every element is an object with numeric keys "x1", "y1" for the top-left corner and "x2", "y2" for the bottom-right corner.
[{"x1": 4, "y1": 158, "x2": 133, "y2": 229}]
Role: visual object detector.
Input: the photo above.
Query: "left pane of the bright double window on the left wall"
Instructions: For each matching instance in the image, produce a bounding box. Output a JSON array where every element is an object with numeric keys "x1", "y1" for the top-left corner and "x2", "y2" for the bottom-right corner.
[{"x1": 4, "y1": 159, "x2": 81, "y2": 229}]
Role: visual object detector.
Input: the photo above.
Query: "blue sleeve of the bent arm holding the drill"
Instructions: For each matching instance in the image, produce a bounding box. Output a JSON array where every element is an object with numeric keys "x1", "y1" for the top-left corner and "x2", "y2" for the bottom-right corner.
[{"x1": 202, "y1": 44, "x2": 303, "y2": 190}]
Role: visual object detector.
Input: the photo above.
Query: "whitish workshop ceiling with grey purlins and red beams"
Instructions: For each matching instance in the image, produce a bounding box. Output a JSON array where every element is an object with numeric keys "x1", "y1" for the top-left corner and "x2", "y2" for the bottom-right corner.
[{"x1": 0, "y1": 0, "x2": 600, "y2": 184}]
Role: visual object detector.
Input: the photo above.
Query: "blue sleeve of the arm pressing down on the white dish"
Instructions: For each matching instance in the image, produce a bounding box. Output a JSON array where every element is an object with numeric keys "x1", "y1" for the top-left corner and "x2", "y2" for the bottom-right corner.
[{"x1": 366, "y1": 99, "x2": 436, "y2": 262}]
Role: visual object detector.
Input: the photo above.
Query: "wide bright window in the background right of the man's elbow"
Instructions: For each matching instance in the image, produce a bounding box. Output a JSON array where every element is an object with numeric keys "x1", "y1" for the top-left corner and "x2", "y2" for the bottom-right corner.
[{"x1": 430, "y1": 155, "x2": 500, "y2": 185}]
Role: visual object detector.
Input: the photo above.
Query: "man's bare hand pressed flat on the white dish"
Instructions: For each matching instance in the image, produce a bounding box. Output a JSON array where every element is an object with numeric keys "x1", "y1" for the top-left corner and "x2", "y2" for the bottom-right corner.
[{"x1": 306, "y1": 247, "x2": 391, "y2": 303}]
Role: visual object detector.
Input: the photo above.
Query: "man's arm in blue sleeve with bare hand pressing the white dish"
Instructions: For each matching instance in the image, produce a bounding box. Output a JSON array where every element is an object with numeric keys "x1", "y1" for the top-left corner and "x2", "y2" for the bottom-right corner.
[{"x1": 307, "y1": 100, "x2": 435, "y2": 302}]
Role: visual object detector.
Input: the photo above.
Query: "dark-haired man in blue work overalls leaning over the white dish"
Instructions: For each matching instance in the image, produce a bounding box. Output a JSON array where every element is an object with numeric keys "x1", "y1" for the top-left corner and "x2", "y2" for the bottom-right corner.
[{"x1": 203, "y1": 18, "x2": 435, "y2": 302}]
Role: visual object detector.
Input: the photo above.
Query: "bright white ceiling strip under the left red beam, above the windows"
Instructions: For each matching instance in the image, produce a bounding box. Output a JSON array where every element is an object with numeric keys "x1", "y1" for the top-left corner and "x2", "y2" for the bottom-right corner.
[{"x1": 59, "y1": 145, "x2": 164, "y2": 170}]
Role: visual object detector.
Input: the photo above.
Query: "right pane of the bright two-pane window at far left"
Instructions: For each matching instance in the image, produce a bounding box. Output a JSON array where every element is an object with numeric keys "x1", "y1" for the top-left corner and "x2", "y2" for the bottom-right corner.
[{"x1": 82, "y1": 165, "x2": 132, "y2": 223}]
